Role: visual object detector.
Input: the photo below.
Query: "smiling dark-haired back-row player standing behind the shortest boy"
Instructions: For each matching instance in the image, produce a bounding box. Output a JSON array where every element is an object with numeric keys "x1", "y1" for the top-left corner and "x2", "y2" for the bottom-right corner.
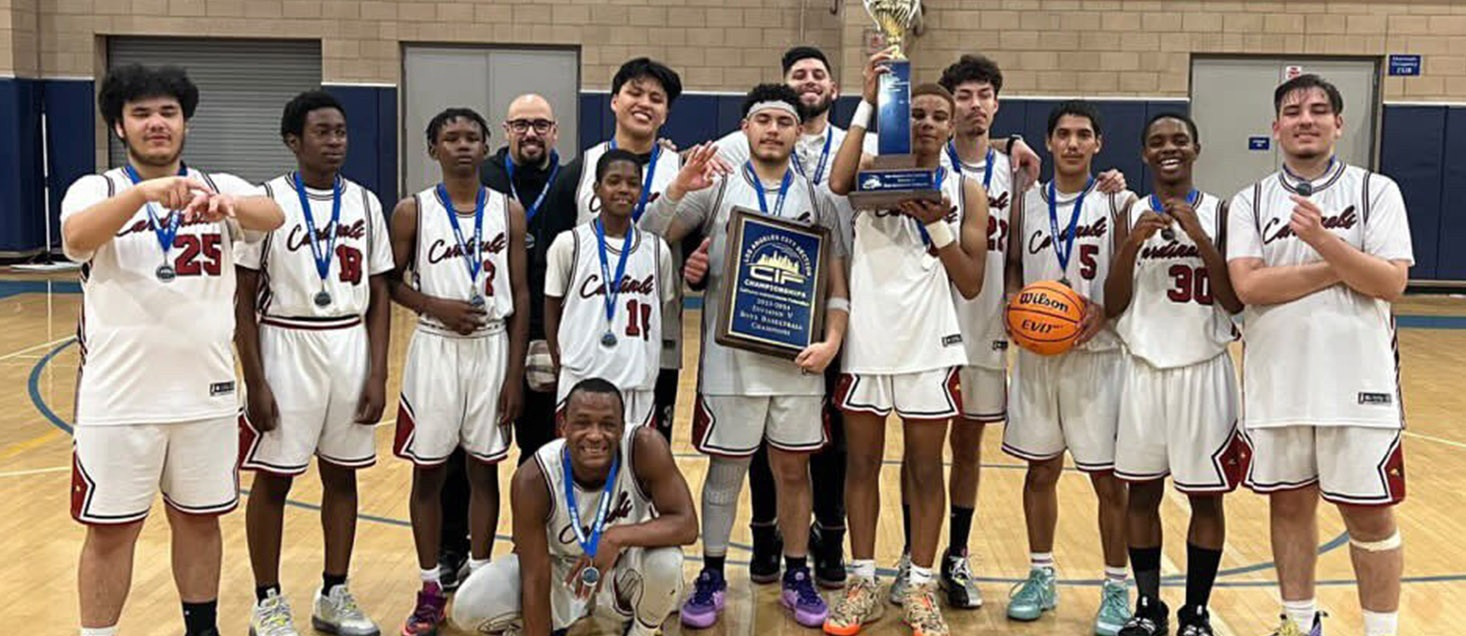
[{"x1": 544, "y1": 57, "x2": 682, "y2": 440}]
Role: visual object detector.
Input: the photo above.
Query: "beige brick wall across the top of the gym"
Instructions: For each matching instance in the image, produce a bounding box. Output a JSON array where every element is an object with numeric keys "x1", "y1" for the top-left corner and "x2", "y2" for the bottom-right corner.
[{"x1": 0, "y1": 0, "x2": 1466, "y2": 101}]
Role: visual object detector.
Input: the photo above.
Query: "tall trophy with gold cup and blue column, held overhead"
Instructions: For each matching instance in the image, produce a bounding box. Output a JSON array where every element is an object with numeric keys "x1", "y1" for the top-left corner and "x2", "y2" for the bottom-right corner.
[{"x1": 849, "y1": 0, "x2": 941, "y2": 210}]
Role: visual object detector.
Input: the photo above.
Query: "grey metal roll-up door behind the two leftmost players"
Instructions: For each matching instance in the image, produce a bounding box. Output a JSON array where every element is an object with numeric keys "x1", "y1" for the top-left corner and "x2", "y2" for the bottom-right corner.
[{"x1": 107, "y1": 37, "x2": 321, "y2": 183}]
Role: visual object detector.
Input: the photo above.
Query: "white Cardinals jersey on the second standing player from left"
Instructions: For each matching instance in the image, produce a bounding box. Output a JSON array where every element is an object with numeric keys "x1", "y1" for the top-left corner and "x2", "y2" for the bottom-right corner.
[{"x1": 239, "y1": 173, "x2": 393, "y2": 327}]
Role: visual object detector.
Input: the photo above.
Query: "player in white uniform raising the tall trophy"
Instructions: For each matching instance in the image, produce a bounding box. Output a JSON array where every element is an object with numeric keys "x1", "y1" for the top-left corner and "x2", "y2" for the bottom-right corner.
[{"x1": 824, "y1": 51, "x2": 988, "y2": 636}]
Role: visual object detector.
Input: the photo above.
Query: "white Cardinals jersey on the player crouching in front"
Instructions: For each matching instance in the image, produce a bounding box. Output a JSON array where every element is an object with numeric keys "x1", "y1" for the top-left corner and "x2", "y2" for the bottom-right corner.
[{"x1": 535, "y1": 426, "x2": 657, "y2": 562}]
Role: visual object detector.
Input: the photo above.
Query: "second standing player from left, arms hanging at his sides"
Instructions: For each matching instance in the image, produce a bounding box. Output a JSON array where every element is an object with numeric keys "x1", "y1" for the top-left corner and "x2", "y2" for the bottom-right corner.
[{"x1": 235, "y1": 91, "x2": 393, "y2": 636}]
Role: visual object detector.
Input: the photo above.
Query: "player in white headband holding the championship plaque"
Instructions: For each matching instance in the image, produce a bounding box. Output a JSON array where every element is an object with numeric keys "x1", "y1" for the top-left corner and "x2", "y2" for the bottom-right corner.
[{"x1": 642, "y1": 84, "x2": 850, "y2": 629}]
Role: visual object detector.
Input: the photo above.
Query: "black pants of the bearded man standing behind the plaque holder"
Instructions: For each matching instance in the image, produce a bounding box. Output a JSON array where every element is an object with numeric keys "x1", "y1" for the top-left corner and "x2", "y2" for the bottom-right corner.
[{"x1": 748, "y1": 359, "x2": 844, "y2": 529}]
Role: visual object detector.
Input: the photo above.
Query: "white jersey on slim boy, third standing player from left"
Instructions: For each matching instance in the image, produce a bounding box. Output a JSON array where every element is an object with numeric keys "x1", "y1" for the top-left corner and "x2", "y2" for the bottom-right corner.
[{"x1": 412, "y1": 186, "x2": 515, "y2": 334}]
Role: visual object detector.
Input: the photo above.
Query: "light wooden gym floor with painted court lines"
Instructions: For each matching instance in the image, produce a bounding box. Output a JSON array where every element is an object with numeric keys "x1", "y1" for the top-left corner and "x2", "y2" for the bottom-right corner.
[{"x1": 0, "y1": 274, "x2": 1466, "y2": 636}]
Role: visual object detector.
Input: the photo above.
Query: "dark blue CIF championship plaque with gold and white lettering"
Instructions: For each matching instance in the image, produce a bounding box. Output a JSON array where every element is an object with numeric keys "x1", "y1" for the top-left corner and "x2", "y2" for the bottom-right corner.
[{"x1": 715, "y1": 207, "x2": 828, "y2": 360}]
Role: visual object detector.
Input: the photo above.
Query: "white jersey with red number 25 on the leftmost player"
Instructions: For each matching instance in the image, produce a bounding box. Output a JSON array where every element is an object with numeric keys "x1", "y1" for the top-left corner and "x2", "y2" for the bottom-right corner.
[{"x1": 62, "y1": 169, "x2": 262, "y2": 426}]
